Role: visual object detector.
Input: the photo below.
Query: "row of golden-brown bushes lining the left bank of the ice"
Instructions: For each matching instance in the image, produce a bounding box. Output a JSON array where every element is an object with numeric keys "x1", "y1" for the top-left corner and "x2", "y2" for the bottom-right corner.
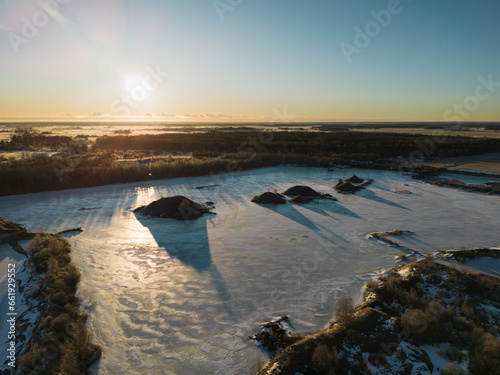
[{"x1": 18, "y1": 234, "x2": 101, "y2": 375}]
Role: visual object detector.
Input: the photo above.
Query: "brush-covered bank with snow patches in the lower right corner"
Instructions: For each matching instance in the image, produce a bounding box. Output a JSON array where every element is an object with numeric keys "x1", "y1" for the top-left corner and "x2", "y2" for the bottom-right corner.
[{"x1": 251, "y1": 249, "x2": 500, "y2": 375}]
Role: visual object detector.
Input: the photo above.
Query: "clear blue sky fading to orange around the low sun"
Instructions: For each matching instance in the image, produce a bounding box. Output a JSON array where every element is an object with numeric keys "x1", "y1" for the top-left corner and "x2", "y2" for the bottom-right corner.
[{"x1": 0, "y1": 0, "x2": 500, "y2": 121}]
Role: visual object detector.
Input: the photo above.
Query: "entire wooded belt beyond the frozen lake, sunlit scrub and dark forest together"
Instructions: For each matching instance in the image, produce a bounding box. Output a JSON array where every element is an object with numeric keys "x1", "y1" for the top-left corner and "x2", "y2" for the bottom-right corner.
[{"x1": 0, "y1": 131, "x2": 500, "y2": 195}]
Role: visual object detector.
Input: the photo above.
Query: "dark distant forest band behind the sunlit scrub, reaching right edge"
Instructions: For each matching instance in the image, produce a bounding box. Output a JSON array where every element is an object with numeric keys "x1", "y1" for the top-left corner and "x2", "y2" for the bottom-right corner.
[{"x1": 96, "y1": 131, "x2": 500, "y2": 158}]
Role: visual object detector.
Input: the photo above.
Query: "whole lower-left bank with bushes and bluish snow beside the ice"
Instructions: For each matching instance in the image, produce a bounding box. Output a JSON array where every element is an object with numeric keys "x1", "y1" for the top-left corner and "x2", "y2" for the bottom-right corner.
[{"x1": 0, "y1": 222, "x2": 102, "y2": 375}]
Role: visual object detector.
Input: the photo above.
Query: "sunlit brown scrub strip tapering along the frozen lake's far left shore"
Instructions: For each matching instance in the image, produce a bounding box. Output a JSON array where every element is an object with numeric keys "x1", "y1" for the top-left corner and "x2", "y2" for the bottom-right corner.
[{"x1": 0, "y1": 153, "x2": 282, "y2": 196}]
